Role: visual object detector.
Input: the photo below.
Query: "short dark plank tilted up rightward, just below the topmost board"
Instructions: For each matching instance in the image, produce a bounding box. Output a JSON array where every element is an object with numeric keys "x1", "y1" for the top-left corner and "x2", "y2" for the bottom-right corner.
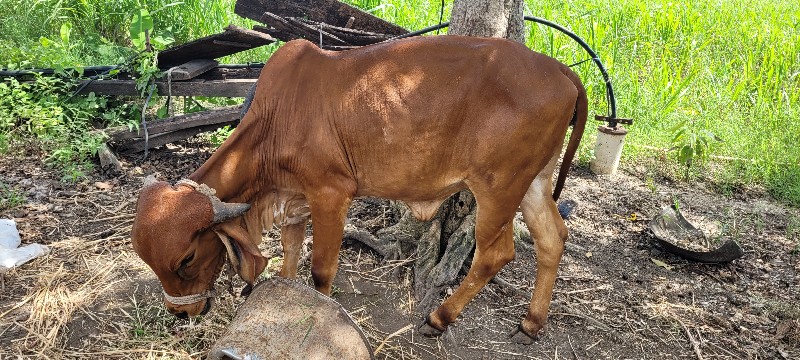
[{"x1": 158, "y1": 25, "x2": 275, "y2": 68}]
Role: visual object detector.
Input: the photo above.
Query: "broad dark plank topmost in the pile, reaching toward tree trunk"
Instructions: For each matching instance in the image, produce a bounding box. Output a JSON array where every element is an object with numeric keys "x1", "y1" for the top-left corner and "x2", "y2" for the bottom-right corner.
[{"x1": 233, "y1": 0, "x2": 408, "y2": 35}]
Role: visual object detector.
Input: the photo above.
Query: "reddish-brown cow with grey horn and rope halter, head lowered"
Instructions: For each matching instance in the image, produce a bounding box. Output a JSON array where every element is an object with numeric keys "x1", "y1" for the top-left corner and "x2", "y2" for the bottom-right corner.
[{"x1": 132, "y1": 36, "x2": 587, "y2": 343}]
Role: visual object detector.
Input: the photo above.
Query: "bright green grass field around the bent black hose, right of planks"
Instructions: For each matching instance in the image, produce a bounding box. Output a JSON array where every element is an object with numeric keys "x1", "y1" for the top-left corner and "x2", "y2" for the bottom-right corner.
[{"x1": 351, "y1": 0, "x2": 800, "y2": 206}]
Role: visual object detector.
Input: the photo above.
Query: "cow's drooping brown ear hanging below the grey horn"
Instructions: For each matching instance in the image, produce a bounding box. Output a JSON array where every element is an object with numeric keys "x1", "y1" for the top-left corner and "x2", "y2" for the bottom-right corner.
[{"x1": 214, "y1": 221, "x2": 267, "y2": 288}]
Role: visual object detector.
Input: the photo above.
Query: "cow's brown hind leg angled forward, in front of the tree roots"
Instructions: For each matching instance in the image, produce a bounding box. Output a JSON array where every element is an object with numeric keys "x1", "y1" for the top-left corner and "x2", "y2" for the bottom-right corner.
[{"x1": 419, "y1": 192, "x2": 516, "y2": 336}]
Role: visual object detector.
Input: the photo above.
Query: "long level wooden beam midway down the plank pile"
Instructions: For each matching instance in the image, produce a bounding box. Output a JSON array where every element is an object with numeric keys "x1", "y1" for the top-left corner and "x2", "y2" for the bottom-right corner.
[{"x1": 78, "y1": 79, "x2": 256, "y2": 97}]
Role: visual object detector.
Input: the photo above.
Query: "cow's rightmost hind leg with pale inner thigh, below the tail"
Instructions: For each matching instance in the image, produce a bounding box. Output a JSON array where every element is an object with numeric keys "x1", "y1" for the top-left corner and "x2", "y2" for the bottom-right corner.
[{"x1": 512, "y1": 159, "x2": 567, "y2": 344}]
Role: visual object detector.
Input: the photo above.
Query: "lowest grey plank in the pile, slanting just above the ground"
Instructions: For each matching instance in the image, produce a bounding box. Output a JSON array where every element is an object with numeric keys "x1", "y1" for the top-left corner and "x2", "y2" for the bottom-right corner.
[{"x1": 104, "y1": 106, "x2": 242, "y2": 141}]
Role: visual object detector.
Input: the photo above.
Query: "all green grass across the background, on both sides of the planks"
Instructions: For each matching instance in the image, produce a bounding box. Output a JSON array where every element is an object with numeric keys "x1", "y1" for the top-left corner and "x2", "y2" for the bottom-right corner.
[{"x1": 0, "y1": 0, "x2": 800, "y2": 206}]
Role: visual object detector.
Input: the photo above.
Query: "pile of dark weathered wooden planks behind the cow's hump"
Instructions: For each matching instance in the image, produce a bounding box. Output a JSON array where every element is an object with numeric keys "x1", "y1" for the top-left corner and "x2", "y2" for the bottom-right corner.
[{"x1": 100, "y1": 0, "x2": 408, "y2": 153}]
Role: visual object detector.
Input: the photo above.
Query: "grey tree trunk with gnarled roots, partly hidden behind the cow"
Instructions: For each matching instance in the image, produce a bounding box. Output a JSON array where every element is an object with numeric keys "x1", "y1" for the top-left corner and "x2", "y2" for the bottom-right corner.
[{"x1": 346, "y1": 0, "x2": 530, "y2": 313}]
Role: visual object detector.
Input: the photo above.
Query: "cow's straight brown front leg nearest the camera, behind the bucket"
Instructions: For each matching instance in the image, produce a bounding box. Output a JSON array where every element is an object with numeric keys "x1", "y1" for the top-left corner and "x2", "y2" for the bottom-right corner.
[{"x1": 307, "y1": 188, "x2": 352, "y2": 295}]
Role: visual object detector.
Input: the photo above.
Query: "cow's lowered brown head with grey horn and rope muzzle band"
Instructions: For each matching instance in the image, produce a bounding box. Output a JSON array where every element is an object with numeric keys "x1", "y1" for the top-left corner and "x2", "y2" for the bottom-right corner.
[{"x1": 131, "y1": 180, "x2": 266, "y2": 318}]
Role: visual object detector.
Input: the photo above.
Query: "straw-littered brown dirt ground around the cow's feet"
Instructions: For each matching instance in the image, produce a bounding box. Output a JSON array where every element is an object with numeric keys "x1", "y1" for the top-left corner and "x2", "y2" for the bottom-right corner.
[{"x1": 0, "y1": 140, "x2": 800, "y2": 359}]
